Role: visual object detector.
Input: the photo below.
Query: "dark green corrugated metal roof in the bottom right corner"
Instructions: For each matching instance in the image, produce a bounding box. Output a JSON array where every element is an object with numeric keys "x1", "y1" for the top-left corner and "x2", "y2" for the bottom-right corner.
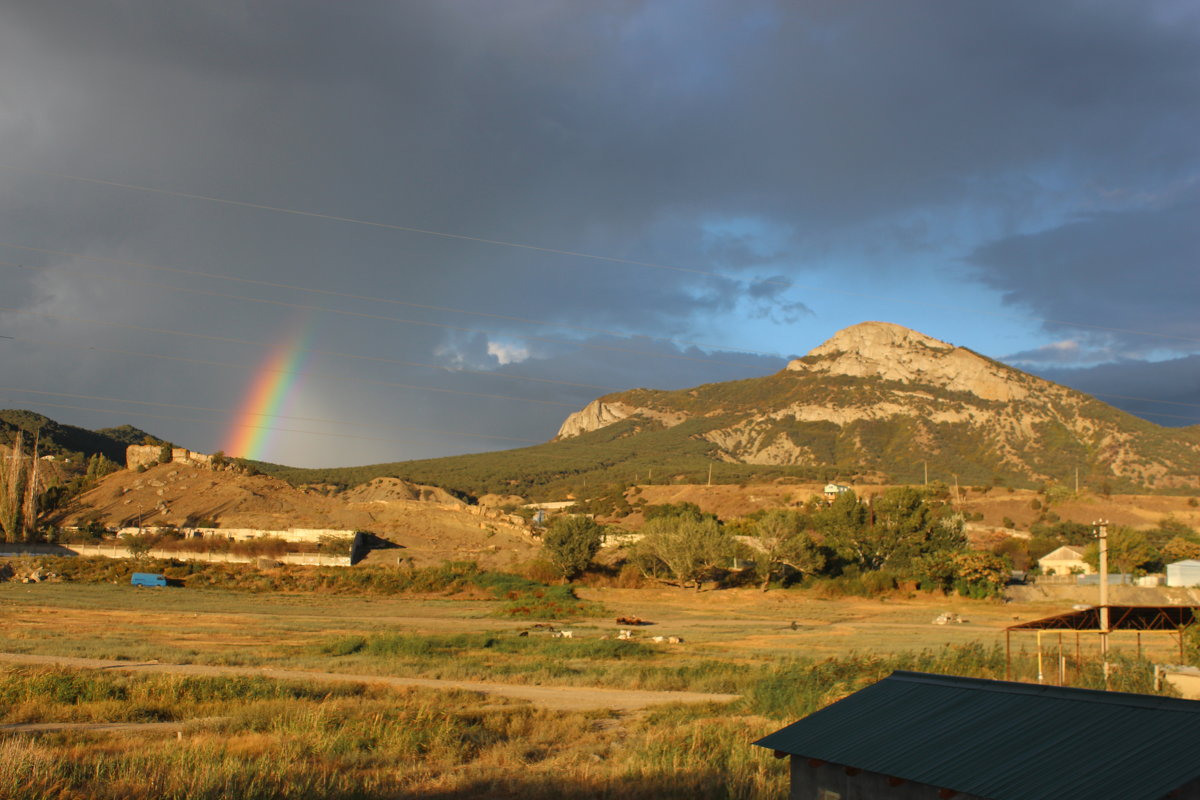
[{"x1": 755, "y1": 670, "x2": 1200, "y2": 800}]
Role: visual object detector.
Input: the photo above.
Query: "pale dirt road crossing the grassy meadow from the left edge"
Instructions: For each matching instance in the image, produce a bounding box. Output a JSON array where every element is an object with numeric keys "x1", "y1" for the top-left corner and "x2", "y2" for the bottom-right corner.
[{"x1": 0, "y1": 652, "x2": 738, "y2": 711}]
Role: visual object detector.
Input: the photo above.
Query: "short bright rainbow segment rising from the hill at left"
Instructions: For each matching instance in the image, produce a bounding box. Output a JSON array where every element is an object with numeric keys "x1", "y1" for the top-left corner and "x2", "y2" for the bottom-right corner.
[{"x1": 224, "y1": 326, "x2": 310, "y2": 459}]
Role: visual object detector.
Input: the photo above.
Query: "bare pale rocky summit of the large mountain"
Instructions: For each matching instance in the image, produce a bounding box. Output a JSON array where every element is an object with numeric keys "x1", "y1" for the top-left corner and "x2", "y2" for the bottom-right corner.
[{"x1": 787, "y1": 321, "x2": 1028, "y2": 402}]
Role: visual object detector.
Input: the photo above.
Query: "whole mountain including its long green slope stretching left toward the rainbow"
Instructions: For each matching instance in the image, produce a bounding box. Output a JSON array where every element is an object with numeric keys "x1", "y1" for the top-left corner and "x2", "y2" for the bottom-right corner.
[{"x1": 270, "y1": 323, "x2": 1200, "y2": 498}]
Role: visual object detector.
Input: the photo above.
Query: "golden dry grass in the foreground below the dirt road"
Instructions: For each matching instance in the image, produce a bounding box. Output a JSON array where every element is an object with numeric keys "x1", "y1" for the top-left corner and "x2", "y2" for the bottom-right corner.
[{"x1": 0, "y1": 667, "x2": 782, "y2": 800}]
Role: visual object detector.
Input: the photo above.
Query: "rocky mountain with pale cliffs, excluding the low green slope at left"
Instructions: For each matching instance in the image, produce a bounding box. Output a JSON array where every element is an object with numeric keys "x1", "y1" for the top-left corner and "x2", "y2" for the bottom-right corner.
[{"x1": 556, "y1": 323, "x2": 1200, "y2": 489}]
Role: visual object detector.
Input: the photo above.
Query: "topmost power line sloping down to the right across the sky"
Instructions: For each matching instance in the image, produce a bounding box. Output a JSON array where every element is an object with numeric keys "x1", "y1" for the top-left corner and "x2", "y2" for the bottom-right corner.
[{"x1": 0, "y1": 164, "x2": 1200, "y2": 343}]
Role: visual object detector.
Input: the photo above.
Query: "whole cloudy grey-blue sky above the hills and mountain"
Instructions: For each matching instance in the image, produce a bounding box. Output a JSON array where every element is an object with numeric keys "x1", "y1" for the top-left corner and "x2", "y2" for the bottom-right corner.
[{"x1": 0, "y1": 0, "x2": 1200, "y2": 467}]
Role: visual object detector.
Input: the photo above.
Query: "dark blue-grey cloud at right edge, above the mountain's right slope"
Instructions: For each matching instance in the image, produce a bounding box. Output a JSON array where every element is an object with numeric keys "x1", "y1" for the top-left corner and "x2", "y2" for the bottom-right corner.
[{"x1": 970, "y1": 186, "x2": 1200, "y2": 357}]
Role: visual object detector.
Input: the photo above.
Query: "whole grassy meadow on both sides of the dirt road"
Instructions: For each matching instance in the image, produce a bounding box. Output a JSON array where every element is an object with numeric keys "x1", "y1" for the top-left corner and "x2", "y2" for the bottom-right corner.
[{"x1": 0, "y1": 556, "x2": 1172, "y2": 800}]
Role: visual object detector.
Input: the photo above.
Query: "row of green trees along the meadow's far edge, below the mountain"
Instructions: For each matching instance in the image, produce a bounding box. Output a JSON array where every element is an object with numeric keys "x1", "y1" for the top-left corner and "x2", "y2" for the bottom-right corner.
[{"x1": 544, "y1": 487, "x2": 1012, "y2": 596}]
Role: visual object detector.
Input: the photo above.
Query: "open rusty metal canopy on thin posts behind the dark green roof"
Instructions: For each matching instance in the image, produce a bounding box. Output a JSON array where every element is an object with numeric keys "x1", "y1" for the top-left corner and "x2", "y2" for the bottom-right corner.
[{"x1": 1004, "y1": 606, "x2": 1200, "y2": 684}]
